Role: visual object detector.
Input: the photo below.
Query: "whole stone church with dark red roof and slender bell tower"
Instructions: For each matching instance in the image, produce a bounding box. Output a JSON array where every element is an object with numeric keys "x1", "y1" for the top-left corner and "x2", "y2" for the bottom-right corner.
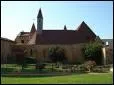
[{"x1": 1, "y1": 9, "x2": 102, "y2": 63}]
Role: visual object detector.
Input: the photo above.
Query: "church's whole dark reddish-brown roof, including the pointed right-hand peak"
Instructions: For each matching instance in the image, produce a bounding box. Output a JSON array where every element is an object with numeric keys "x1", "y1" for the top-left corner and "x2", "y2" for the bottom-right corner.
[{"x1": 29, "y1": 22, "x2": 96, "y2": 44}]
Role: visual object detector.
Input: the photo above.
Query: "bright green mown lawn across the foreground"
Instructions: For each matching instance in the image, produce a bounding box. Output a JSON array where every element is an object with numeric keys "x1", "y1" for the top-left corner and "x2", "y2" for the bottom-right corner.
[{"x1": 1, "y1": 73, "x2": 113, "y2": 84}]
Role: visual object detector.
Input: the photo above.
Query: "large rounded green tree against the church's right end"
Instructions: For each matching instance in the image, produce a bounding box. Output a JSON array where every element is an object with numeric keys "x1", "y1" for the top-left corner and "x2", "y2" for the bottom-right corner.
[{"x1": 82, "y1": 42, "x2": 102, "y2": 64}]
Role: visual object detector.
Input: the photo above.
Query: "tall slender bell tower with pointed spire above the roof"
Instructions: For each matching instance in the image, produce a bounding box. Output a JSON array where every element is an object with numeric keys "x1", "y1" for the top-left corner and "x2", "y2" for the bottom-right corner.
[{"x1": 37, "y1": 8, "x2": 43, "y2": 34}]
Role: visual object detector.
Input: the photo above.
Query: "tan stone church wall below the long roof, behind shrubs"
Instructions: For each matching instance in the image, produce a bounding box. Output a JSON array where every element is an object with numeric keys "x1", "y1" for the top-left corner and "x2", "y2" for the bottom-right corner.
[{"x1": 26, "y1": 44, "x2": 84, "y2": 63}]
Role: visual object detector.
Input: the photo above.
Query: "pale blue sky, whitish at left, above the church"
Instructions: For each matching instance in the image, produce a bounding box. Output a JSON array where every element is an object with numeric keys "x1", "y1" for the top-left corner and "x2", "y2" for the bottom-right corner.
[{"x1": 1, "y1": 1, "x2": 113, "y2": 40}]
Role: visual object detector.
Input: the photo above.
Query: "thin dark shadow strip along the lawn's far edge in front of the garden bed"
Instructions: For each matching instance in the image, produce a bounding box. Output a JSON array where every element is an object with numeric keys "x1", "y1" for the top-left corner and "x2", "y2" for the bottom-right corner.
[{"x1": 1, "y1": 72, "x2": 87, "y2": 78}]
